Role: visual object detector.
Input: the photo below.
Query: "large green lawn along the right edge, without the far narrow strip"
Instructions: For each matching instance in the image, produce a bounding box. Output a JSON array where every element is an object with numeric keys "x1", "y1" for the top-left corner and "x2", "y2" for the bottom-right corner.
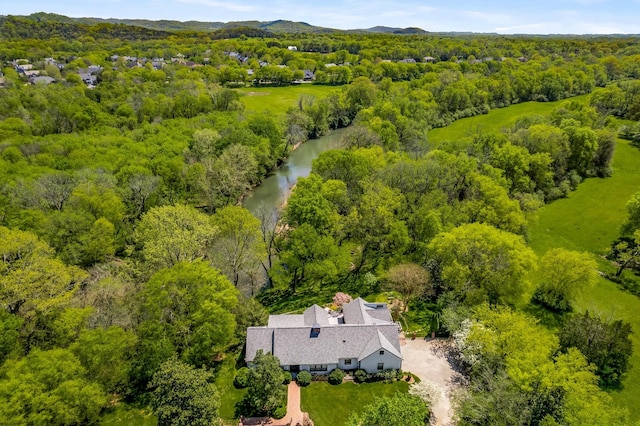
[{"x1": 529, "y1": 140, "x2": 640, "y2": 421}]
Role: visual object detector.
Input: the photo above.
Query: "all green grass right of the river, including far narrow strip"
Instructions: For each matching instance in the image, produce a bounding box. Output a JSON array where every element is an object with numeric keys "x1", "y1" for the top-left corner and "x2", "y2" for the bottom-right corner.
[{"x1": 429, "y1": 96, "x2": 640, "y2": 421}]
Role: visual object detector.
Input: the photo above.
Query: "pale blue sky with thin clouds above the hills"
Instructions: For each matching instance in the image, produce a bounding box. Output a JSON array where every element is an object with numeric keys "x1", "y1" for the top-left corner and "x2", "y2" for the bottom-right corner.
[{"x1": 0, "y1": 0, "x2": 640, "y2": 34}]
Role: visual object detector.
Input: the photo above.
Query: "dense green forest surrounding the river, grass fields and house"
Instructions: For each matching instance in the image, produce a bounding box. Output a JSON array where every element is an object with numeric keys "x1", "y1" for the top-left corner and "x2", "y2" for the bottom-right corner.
[{"x1": 0, "y1": 17, "x2": 640, "y2": 425}]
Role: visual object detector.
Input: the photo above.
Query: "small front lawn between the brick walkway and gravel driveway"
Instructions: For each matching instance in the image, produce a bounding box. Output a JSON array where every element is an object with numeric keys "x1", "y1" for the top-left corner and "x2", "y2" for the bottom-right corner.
[{"x1": 301, "y1": 381, "x2": 409, "y2": 426}]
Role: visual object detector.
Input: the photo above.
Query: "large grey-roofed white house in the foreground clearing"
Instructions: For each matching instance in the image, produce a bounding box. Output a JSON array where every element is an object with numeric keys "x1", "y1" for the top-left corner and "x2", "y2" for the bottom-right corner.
[{"x1": 245, "y1": 298, "x2": 402, "y2": 374}]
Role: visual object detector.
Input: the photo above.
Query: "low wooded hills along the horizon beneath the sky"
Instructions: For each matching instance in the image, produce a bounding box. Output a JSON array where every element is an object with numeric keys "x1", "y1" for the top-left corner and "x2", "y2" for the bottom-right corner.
[{"x1": 8, "y1": 12, "x2": 426, "y2": 34}]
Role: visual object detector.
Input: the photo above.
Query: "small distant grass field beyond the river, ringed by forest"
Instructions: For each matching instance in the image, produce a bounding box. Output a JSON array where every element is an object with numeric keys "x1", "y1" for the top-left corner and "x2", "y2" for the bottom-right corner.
[{"x1": 238, "y1": 84, "x2": 342, "y2": 114}]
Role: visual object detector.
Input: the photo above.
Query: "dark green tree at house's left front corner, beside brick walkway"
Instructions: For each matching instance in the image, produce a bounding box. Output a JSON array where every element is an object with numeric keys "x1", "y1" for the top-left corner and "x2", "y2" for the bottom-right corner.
[{"x1": 245, "y1": 350, "x2": 286, "y2": 415}]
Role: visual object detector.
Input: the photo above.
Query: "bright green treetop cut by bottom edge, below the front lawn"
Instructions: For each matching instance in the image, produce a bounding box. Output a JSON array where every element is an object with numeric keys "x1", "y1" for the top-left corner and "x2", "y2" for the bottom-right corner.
[{"x1": 347, "y1": 393, "x2": 429, "y2": 426}]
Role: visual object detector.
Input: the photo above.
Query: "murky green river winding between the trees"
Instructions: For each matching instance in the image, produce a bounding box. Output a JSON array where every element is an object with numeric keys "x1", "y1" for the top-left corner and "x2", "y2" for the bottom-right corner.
[{"x1": 243, "y1": 129, "x2": 345, "y2": 215}]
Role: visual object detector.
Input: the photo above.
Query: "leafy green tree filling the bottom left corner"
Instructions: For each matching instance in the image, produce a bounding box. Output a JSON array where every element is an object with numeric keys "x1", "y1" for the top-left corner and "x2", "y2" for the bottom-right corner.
[{"x1": 0, "y1": 349, "x2": 107, "y2": 425}]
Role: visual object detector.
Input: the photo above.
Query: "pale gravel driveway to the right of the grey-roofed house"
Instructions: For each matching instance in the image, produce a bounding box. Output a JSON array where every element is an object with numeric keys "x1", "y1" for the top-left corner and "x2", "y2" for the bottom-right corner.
[{"x1": 400, "y1": 337, "x2": 459, "y2": 426}]
